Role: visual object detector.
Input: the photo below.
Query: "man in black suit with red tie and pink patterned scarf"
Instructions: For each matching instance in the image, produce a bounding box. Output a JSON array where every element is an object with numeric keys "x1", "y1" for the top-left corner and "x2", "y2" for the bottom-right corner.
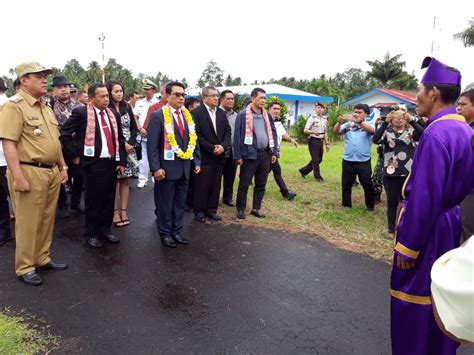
[{"x1": 60, "y1": 84, "x2": 127, "y2": 248}]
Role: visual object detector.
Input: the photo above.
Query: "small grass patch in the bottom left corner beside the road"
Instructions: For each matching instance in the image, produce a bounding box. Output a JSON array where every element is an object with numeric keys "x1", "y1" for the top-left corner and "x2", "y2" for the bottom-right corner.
[{"x1": 0, "y1": 312, "x2": 57, "y2": 355}]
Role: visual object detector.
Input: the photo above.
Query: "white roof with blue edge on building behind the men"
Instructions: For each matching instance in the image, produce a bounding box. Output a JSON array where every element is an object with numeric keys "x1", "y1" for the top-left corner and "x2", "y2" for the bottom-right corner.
[{"x1": 188, "y1": 84, "x2": 334, "y2": 102}]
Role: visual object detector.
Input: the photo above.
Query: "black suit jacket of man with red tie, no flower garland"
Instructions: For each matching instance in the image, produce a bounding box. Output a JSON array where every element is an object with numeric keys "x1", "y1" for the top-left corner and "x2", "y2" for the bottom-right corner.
[{"x1": 60, "y1": 106, "x2": 127, "y2": 166}]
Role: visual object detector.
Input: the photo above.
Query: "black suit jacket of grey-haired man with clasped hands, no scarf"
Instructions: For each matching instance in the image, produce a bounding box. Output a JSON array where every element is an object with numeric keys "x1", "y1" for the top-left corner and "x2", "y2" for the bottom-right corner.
[{"x1": 192, "y1": 104, "x2": 231, "y2": 166}]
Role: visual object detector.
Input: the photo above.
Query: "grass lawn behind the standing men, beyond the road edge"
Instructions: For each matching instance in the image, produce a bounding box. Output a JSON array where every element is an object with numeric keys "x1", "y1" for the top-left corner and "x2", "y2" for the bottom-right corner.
[{"x1": 221, "y1": 142, "x2": 393, "y2": 260}]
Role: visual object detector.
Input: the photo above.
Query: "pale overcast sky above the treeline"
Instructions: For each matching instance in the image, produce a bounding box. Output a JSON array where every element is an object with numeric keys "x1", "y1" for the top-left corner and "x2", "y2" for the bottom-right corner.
[{"x1": 0, "y1": 0, "x2": 474, "y2": 87}]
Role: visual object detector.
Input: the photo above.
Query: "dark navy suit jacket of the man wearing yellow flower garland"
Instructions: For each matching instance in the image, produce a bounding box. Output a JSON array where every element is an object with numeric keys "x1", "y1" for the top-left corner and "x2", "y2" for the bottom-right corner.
[{"x1": 147, "y1": 109, "x2": 201, "y2": 180}]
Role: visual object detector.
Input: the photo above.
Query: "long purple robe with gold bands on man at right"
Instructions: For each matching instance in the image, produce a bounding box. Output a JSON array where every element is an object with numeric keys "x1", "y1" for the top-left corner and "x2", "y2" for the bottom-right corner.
[{"x1": 390, "y1": 107, "x2": 474, "y2": 354}]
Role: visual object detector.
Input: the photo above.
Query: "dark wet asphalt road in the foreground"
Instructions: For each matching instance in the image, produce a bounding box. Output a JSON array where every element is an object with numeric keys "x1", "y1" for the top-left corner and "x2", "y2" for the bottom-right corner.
[{"x1": 0, "y1": 187, "x2": 390, "y2": 354}]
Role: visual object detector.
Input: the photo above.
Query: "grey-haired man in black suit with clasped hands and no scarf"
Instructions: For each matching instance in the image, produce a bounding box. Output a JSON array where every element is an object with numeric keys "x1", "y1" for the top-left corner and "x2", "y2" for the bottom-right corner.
[{"x1": 193, "y1": 86, "x2": 231, "y2": 222}]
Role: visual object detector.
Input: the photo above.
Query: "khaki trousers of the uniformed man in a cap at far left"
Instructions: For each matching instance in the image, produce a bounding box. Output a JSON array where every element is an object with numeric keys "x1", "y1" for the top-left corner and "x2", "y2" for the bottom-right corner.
[{"x1": 7, "y1": 165, "x2": 61, "y2": 276}]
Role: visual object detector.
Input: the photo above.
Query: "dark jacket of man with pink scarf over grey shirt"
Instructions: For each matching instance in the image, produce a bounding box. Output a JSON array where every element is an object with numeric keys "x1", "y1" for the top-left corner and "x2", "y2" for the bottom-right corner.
[{"x1": 233, "y1": 108, "x2": 279, "y2": 160}]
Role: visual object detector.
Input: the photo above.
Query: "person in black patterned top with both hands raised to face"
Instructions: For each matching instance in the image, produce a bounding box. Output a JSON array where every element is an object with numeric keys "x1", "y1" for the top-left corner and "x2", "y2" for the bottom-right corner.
[{"x1": 372, "y1": 109, "x2": 423, "y2": 239}]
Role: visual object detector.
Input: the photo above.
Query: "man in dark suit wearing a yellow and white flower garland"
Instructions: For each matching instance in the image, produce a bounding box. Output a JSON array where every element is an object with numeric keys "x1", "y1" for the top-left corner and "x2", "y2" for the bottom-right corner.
[{"x1": 147, "y1": 82, "x2": 201, "y2": 248}]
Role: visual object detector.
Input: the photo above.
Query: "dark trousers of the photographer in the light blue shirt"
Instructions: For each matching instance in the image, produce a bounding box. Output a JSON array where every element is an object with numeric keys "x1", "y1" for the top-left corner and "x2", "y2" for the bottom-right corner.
[{"x1": 342, "y1": 159, "x2": 375, "y2": 209}]
